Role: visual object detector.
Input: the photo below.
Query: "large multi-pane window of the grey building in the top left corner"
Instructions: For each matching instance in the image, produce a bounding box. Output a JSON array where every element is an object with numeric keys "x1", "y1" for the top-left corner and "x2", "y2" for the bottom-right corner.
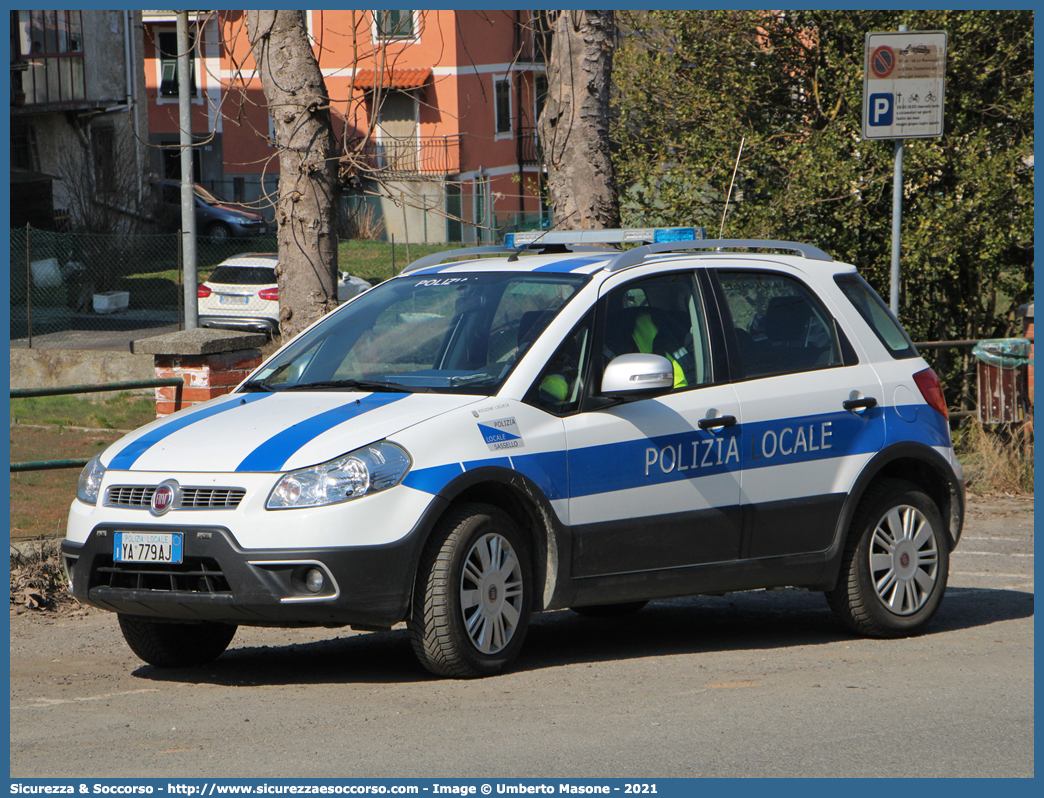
[{"x1": 11, "y1": 10, "x2": 87, "y2": 104}]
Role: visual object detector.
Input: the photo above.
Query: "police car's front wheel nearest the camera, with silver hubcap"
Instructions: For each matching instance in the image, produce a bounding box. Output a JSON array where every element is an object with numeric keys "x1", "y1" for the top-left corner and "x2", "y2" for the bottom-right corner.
[{"x1": 406, "y1": 504, "x2": 532, "y2": 679}]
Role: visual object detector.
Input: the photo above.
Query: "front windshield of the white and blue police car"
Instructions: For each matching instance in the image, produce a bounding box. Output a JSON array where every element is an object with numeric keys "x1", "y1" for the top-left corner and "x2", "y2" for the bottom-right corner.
[{"x1": 241, "y1": 273, "x2": 589, "y2": 396}]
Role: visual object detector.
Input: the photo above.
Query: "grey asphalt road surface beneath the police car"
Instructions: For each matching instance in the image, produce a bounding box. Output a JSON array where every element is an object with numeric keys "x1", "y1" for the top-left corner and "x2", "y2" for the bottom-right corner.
[{"x1": 10, "y1": 499, "x2": 1034, "y2": 778}]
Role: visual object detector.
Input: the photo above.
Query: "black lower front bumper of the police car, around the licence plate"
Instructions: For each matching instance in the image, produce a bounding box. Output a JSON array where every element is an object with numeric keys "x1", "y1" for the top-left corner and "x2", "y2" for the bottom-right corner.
[{"x1": 62, "y1": 523, "x2": 436, "y2": 627}]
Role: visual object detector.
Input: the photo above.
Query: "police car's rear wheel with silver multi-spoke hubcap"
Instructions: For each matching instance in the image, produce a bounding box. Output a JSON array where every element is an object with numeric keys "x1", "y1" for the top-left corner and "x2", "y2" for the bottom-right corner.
[{"x1": 826, "y1": 479, "x2": 950, "y2": 637}]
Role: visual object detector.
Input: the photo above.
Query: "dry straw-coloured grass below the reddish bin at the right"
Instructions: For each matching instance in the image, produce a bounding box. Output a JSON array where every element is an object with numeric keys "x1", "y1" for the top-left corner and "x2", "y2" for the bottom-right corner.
[{"x1": 953, "y1": 419, "x2": 1034, "y2": 495}]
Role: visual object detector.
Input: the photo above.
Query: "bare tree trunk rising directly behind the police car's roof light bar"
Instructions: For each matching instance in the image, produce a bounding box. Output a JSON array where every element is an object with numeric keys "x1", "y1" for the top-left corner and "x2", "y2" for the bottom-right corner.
[{"x1": 538, "y1": 10, "x2": 620, "y2": 230}]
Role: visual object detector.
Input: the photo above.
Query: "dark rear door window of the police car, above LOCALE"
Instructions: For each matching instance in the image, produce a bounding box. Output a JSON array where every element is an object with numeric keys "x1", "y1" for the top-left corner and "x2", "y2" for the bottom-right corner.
[{"x1": 717, "y1": 271, "x2": 843, "y2": 378}]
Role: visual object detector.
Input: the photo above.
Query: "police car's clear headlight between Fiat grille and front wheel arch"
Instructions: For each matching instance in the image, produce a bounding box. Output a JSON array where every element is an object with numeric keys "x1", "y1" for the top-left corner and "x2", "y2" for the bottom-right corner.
[{"x1": 266, "y1": 441, "x2": 410, "y2": 510}]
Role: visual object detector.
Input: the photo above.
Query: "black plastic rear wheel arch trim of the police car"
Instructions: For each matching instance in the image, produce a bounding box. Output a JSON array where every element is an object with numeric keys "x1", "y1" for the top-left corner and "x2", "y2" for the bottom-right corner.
[{"x1": 822, "y1": 442, "x2": 965, "y2": 590}]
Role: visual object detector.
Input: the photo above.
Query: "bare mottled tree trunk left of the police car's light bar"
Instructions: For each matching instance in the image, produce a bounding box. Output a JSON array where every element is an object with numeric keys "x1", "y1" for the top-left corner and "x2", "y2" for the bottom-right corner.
[{"x1": 246, "y1": 10, "x2": 340, "y2": 339}]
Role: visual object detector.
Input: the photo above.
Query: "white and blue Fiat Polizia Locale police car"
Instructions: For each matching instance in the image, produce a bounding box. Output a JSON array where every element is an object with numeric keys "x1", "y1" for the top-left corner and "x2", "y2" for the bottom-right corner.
[{"x1": 62, "y1": 229, "x2": 964, "y2": 677}]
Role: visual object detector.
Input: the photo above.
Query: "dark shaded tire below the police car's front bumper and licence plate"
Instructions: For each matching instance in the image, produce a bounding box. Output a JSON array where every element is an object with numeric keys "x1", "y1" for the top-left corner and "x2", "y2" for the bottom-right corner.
[{"x1": 118, "y1": 615, "x2": 237, "y2": 667}]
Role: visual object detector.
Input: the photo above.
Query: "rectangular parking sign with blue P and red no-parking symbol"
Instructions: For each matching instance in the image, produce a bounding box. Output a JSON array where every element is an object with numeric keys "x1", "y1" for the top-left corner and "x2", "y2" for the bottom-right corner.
[{"x1": 862, "y1": 30, "x2": 946, "y2": 139}]
